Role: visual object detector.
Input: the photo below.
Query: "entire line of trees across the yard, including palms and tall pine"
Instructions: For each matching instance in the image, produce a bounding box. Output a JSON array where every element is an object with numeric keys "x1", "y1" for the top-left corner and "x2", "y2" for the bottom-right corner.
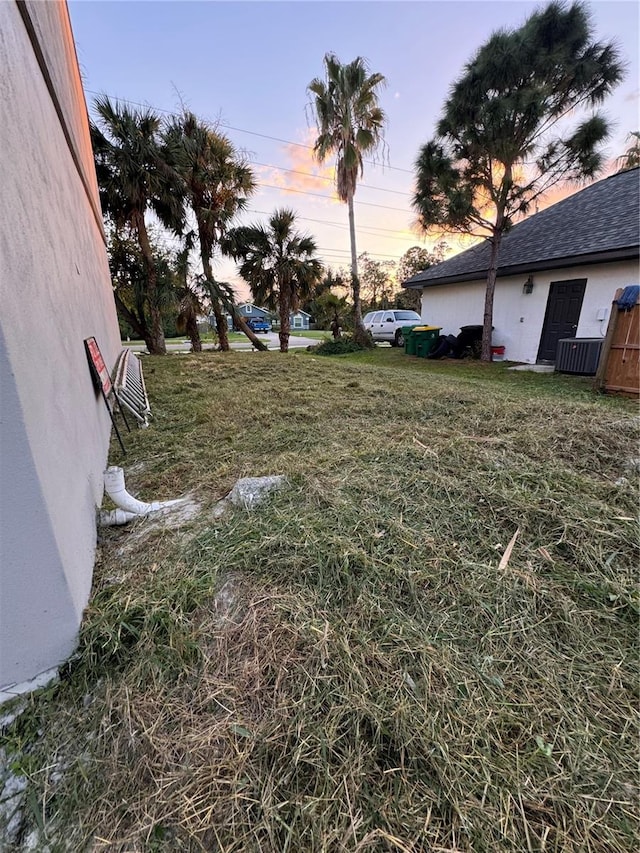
[{"x1": 91, "y1": 0, "x2": 637, "y2": 360}]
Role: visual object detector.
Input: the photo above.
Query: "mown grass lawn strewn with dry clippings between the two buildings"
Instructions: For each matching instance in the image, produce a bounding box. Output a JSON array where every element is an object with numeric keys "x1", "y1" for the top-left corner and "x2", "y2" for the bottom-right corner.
[{"x1": 0, "y1": 348, "x2": 640, "y2": 853}]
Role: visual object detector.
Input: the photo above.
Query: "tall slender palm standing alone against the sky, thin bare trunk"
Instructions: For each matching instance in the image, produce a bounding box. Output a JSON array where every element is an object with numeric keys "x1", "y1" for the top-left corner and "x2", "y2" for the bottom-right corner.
[{"x1": 307, "y1": 53, "x2": 386, "y2": 344}]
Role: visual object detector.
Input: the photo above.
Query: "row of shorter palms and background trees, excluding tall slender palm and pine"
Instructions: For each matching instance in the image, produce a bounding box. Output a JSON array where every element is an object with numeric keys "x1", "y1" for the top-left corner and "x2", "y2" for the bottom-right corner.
[{"x1": 91, "y1": 97, "x2": 441, "y2": 354}]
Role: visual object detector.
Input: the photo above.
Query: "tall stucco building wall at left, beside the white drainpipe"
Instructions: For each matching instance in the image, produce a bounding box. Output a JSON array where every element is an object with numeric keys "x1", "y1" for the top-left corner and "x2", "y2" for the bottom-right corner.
[{"x1": 0, "y1": 0, "x2": 120, "y2": 701}]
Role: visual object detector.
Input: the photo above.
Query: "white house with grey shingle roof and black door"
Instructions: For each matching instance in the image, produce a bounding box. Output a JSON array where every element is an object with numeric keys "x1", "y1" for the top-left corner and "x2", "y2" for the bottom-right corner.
[{"x1": 402, "y1": 169, "x2": 640, "y2": 364}]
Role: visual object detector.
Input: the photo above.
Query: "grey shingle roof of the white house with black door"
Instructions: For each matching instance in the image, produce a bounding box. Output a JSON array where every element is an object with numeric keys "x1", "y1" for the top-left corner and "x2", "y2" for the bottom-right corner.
[{"x1": 402, "y1": 169, "x2": 640, "y2": 287}]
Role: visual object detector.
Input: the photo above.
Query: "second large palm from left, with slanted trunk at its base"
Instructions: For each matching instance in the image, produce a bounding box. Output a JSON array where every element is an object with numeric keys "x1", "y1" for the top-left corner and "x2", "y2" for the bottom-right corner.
[{"x1": 163, "y1": 111, "x2": 266, "y2": 350}]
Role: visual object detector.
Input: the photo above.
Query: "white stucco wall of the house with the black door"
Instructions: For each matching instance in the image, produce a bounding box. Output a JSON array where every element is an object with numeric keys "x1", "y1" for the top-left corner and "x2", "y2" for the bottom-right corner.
[{"x1": 422, "y1": 261, "x2": 638, "y2": 364}]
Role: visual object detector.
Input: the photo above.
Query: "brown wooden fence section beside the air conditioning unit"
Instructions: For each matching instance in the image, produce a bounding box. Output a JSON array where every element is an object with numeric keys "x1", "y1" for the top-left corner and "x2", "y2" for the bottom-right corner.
[{"x1": 594, "y1": 288, "x2": 640, "y2": 395}]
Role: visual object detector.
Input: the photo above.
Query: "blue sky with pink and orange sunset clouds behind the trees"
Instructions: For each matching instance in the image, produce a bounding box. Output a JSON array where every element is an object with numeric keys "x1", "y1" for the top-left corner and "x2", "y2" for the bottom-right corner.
[{"x1": 69, "y1": 0, "x2": 640, "y2": 297}]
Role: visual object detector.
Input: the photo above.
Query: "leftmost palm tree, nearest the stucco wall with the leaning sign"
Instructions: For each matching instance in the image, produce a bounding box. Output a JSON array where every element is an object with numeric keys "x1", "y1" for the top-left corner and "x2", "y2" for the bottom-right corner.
[{"x1": 91, "y1": 96, "x2": 180, "y2": 355}]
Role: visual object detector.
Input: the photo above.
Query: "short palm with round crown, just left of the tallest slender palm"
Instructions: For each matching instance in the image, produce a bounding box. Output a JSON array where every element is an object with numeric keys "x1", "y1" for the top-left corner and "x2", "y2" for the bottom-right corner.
[{"x1": 225, "y1": 209, "x2": 323, "y2": 352}]
